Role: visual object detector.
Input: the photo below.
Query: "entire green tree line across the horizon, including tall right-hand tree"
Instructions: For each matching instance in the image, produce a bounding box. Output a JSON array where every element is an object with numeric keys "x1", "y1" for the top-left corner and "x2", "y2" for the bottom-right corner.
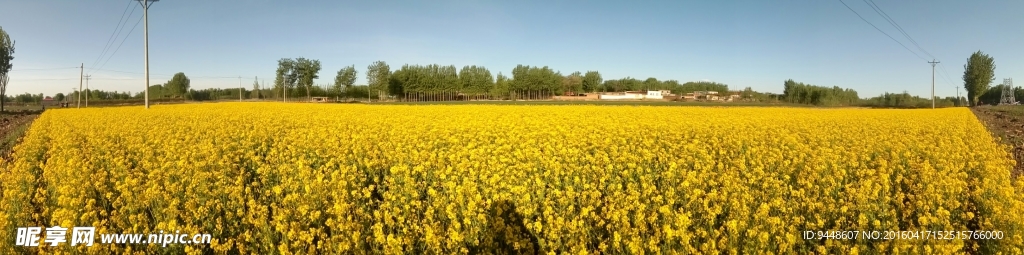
[{"x1": 18, "y1": 51, "x2": 1007, "y2": 108}]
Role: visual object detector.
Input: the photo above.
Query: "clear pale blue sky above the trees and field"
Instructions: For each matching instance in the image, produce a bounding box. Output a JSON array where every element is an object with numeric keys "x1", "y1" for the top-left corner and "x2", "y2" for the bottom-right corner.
[{"x1": 0, "y1": 0, "x2": 1024, "y2": 97}]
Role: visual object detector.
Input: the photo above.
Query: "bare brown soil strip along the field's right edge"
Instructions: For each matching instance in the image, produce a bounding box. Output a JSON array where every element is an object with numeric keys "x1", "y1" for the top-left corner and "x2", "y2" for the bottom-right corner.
[{"x1": 971, "y1": 105, "x2": 1024, "y2": 178}]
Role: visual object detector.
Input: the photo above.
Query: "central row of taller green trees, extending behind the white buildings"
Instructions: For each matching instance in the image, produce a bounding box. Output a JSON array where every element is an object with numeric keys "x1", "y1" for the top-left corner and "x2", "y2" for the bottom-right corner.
[{"x1": 271, "y1": 58, "x2": 753, "y2": 100}]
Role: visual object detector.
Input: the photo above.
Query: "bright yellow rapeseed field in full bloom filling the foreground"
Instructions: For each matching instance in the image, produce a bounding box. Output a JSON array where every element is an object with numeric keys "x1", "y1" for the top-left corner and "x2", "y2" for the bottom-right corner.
[{"x1": 0, "y1": 103, "x2": 1024, "y2": 254}]
